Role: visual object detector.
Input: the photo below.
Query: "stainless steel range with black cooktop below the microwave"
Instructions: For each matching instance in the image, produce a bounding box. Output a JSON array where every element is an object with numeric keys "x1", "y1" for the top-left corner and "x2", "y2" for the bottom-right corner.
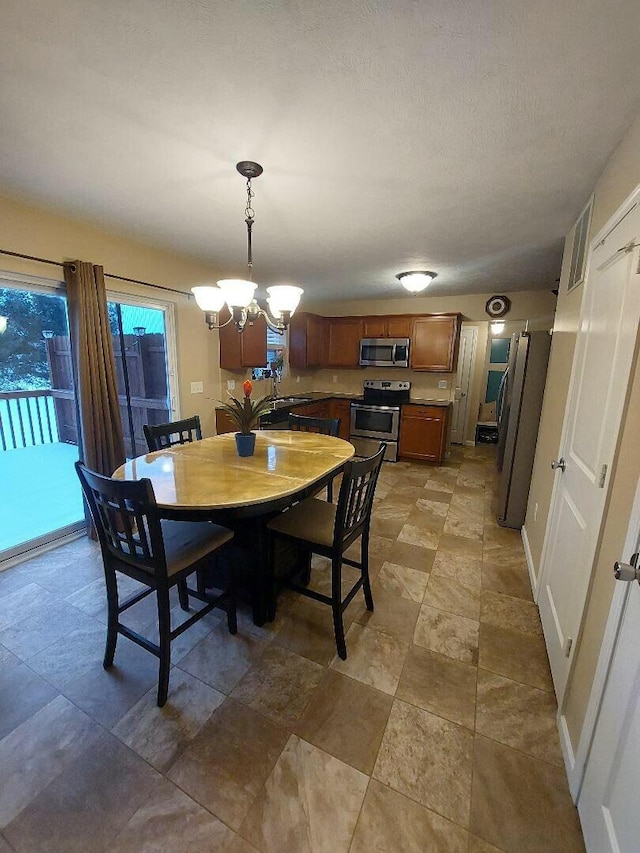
[{"x1": 349, "y1": 379, "x2": 411, "y2": 462}]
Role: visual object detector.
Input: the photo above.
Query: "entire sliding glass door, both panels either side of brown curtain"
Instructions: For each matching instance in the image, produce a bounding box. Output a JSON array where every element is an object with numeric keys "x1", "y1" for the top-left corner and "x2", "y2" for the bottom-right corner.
[{"x1": 0, "y1": 278, "x2": 176, "y2": 563}]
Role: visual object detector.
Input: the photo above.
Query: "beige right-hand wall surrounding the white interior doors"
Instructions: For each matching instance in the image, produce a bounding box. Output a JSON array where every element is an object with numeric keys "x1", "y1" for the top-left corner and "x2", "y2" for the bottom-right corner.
[{"x1": 525, "y1": 110, "x2": 640, "y2": 750}]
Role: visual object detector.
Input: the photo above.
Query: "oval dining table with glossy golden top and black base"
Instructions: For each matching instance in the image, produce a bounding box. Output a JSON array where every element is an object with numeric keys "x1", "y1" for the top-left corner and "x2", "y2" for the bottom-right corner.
[{"x1": 113, "y1": 429, "x2": 355, "y2": 625}]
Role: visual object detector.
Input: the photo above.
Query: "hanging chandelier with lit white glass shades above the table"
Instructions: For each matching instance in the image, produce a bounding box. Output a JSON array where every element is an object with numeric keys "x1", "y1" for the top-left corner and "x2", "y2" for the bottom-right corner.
[{"x1": 191, "y1": 160, "x2": 304, "y2": 335}]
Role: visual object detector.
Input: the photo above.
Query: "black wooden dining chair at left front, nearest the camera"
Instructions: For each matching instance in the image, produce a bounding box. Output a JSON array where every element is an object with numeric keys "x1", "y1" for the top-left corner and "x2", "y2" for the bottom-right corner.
[{"x1": 75, "y1": 462, "x2": 237, "y2": 707}]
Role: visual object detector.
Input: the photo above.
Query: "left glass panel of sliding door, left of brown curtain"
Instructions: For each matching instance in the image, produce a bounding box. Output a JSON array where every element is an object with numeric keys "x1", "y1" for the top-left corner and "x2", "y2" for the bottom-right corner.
[{"x1": 0, "y1": 280, "x2": 84, "y2": 561}]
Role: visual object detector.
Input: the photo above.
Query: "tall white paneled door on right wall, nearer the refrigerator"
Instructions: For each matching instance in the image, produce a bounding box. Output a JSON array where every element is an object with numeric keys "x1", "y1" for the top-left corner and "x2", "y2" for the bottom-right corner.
[{"x1": 538, "y1": 191, "x2": 640, "y2": 702}]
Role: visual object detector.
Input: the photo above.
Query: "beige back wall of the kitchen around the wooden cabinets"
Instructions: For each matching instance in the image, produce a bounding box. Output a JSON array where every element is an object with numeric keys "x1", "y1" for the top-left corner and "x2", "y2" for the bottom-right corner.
[{"x1": 221, "y1": 291, "x2": 556, "y2": 441}]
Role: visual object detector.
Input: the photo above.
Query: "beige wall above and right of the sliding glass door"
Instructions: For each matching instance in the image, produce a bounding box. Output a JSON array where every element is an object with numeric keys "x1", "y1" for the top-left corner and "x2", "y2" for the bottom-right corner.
[{"x1": 0, "y1": 191, "x2": 225, "y2": 435}]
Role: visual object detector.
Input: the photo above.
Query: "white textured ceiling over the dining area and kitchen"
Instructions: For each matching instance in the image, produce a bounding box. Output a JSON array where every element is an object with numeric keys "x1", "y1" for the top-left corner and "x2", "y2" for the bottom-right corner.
[{"x1": 0, "y1": 0, "x2": 640, "y2": 300}]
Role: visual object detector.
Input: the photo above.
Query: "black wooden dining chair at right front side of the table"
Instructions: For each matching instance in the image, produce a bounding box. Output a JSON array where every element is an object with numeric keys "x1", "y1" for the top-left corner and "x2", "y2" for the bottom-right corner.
[{"x1": 267, "y1": 442, "x2": 386, "y2": 660}]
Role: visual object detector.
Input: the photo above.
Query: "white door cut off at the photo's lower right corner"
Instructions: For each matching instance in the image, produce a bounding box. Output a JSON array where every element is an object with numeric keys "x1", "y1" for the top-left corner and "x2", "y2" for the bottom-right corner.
[{"x1": 578, "y1": 480, "x2": 640, "y2": 853}]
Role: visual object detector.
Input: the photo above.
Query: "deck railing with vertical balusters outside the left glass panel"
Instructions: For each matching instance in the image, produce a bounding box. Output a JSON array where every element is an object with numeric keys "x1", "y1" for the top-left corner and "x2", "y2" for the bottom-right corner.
[{"x1": 0, "y1": 389, "x2": 60, "y2": 450}]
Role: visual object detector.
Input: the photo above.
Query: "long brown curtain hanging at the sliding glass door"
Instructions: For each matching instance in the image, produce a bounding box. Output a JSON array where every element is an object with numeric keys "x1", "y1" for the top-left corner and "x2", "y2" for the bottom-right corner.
[{"x1": 64, "y1": 261, "x2": 125, "y2": 477}]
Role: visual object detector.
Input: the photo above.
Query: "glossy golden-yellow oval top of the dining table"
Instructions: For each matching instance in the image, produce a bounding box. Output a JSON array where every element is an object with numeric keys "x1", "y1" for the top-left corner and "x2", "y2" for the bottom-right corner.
[{"x1": 113, "y1": 430, "x2": 355, "y2": 510}]
